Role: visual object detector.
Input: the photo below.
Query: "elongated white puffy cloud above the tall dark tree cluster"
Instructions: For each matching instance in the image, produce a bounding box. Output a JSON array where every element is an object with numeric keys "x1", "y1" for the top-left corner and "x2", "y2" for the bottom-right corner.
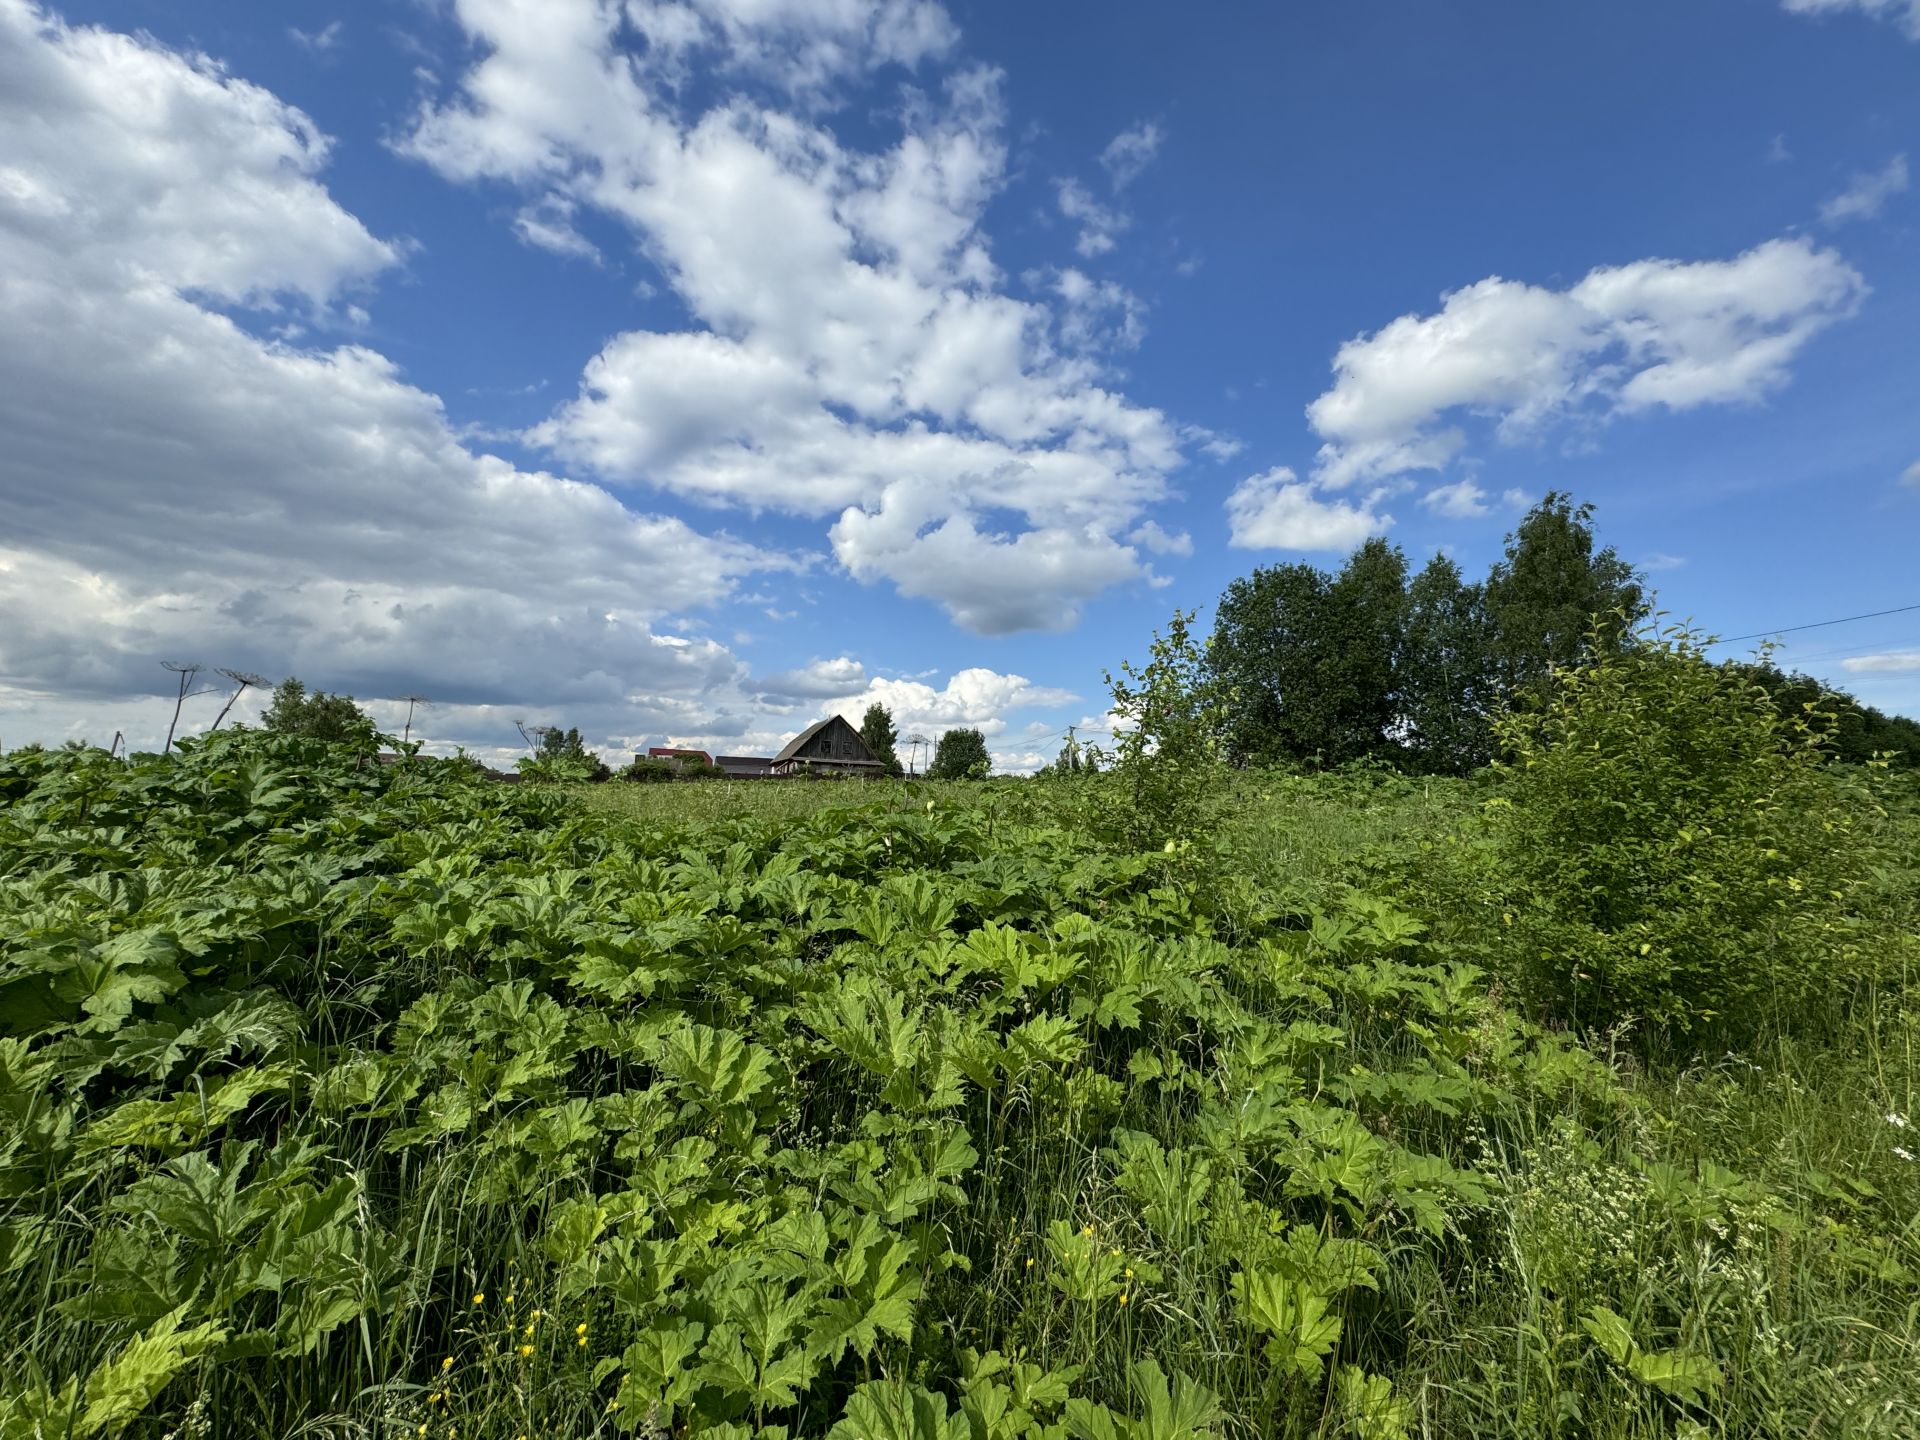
[{"x1": 1308, "y1": 238, "x2": 1866, "y2": 486}]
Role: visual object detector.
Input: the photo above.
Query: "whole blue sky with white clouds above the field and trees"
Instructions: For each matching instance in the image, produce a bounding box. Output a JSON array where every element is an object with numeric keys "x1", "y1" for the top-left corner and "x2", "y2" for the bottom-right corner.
[{"x1": 0, "y1": 0, "x2": 1920, "y2": 768}]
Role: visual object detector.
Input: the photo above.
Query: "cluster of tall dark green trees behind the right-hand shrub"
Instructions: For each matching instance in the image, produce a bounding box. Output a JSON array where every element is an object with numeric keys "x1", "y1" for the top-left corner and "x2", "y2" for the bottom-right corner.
[{"x1": 1208, "y1": 492, "x2": 1647, "y2": 774}]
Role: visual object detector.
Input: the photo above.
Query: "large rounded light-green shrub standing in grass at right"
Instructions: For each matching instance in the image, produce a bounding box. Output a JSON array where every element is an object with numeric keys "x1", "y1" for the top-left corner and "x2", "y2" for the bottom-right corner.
[{"x1": 1496, "y1": 628, "x2": 1872, "y2": 1033}]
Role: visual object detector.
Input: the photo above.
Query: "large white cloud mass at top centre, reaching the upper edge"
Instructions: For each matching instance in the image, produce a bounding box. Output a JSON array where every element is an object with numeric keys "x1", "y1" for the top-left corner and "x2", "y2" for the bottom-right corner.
[{"x1": 403, "y1": 0, "x2": 1183, "y2": 634}]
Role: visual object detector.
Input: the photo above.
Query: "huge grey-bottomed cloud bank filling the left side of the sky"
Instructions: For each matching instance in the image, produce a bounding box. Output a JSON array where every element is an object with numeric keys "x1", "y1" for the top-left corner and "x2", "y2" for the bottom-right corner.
[{"x1": 0, "y1": 0, "x2": 793, "y2": 733}]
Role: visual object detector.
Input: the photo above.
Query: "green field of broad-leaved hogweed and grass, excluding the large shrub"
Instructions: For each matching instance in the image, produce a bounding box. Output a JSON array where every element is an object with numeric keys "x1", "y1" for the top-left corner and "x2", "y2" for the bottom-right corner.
[{"x1": 0, "y1": 735, "x2": 1920, "y2": 1440}]
